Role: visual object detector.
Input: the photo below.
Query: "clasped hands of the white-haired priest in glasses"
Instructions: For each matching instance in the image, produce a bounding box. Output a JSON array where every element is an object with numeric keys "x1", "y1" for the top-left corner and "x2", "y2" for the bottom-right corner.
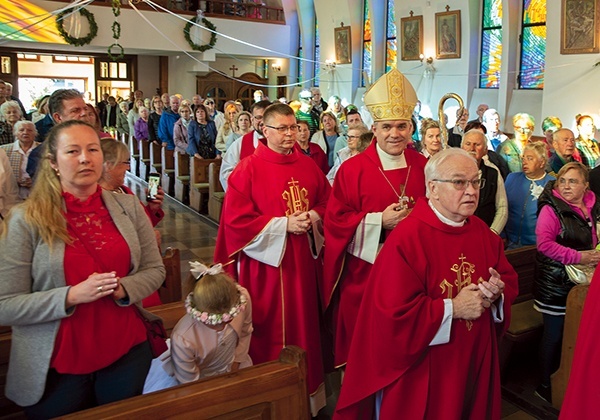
[{"x1": 452, "y1": 267, "x2": 504, "y2": 320}]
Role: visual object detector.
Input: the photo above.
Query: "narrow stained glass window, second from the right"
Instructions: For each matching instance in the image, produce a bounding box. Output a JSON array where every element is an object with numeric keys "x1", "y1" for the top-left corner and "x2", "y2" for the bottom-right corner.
[{"x1": 479, "y1": 0, "x2": 502, "y2": 89}]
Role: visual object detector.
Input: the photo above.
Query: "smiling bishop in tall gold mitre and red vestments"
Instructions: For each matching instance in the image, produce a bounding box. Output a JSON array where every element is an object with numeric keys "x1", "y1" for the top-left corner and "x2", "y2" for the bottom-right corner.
[{"x1": 322, "y1": 69, "x2": 427, "y2": 367}]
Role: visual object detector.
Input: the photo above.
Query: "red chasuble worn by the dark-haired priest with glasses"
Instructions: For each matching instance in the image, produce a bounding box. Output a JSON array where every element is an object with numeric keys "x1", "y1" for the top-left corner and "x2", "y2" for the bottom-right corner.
[{"x1": 215, "y1": 144, "x2": 330, "y2": 394}]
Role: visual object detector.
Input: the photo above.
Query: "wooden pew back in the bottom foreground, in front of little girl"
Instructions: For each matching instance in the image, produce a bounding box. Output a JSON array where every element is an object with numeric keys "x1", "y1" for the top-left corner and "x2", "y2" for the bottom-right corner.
[{"x1": 62, "y1": 346, "x2": 310, "y2": 419}]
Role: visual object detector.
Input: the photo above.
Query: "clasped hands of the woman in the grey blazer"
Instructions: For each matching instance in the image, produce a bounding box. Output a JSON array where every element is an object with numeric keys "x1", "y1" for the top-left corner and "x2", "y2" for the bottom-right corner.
[{"x1": 66, "y1": 271, "x2": 126, "y2": 308}]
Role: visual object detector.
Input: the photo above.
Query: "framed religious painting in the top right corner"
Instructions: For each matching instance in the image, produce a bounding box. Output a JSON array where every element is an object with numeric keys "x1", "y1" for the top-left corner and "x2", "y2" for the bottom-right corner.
[{"x1": 560, "y1": 0, "x2": 600, "y2": 54}]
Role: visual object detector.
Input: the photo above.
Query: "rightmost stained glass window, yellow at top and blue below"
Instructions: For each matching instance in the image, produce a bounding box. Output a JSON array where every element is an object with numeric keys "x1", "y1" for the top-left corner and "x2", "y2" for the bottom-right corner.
[{"x1": 519, "y1": 0, "x2": 546, "y2": 89}]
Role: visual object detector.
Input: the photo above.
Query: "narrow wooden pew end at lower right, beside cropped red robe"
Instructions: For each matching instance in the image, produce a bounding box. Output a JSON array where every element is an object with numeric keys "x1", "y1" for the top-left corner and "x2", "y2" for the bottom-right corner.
[{"x1": 551, "y1": 284, "x2": 590, "y2": 410}]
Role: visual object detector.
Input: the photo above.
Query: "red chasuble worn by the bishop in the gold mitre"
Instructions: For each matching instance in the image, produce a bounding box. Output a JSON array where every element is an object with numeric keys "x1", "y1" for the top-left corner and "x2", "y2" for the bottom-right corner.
[{"x1": 323, "y1": 141, "x2": 427, "y2": 366}]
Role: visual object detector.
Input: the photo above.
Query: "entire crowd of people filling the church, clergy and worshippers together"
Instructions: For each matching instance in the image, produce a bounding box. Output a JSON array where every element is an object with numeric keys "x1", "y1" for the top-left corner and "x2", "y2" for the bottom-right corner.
[{"x1": 0, "y1": 65, "x2": 600, "y2": 419}]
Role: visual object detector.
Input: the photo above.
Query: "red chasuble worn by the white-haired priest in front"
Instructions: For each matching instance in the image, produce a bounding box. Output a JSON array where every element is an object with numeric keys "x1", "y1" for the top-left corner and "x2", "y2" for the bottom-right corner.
[{"x1": 334, "y1": 199, "x2": 518, "y2": 419}]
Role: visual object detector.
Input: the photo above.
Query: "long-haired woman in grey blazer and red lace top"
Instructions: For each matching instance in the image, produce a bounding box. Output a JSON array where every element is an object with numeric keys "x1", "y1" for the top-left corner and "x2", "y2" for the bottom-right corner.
[{"x1": 0, "y1": 120, "x2": 165, "y2": 418}]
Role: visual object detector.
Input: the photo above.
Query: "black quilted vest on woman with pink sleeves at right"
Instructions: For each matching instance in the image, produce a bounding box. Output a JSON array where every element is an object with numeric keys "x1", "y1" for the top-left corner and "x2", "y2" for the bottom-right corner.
[{"x1": 533, "y1": 181, "x2": 600, "y2": 307}]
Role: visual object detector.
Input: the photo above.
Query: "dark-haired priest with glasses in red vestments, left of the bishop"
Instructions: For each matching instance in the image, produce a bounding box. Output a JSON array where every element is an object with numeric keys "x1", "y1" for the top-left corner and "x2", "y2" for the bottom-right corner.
[{"x1": 215, "y1": 103, "x2": 330, "y2": 416}]
